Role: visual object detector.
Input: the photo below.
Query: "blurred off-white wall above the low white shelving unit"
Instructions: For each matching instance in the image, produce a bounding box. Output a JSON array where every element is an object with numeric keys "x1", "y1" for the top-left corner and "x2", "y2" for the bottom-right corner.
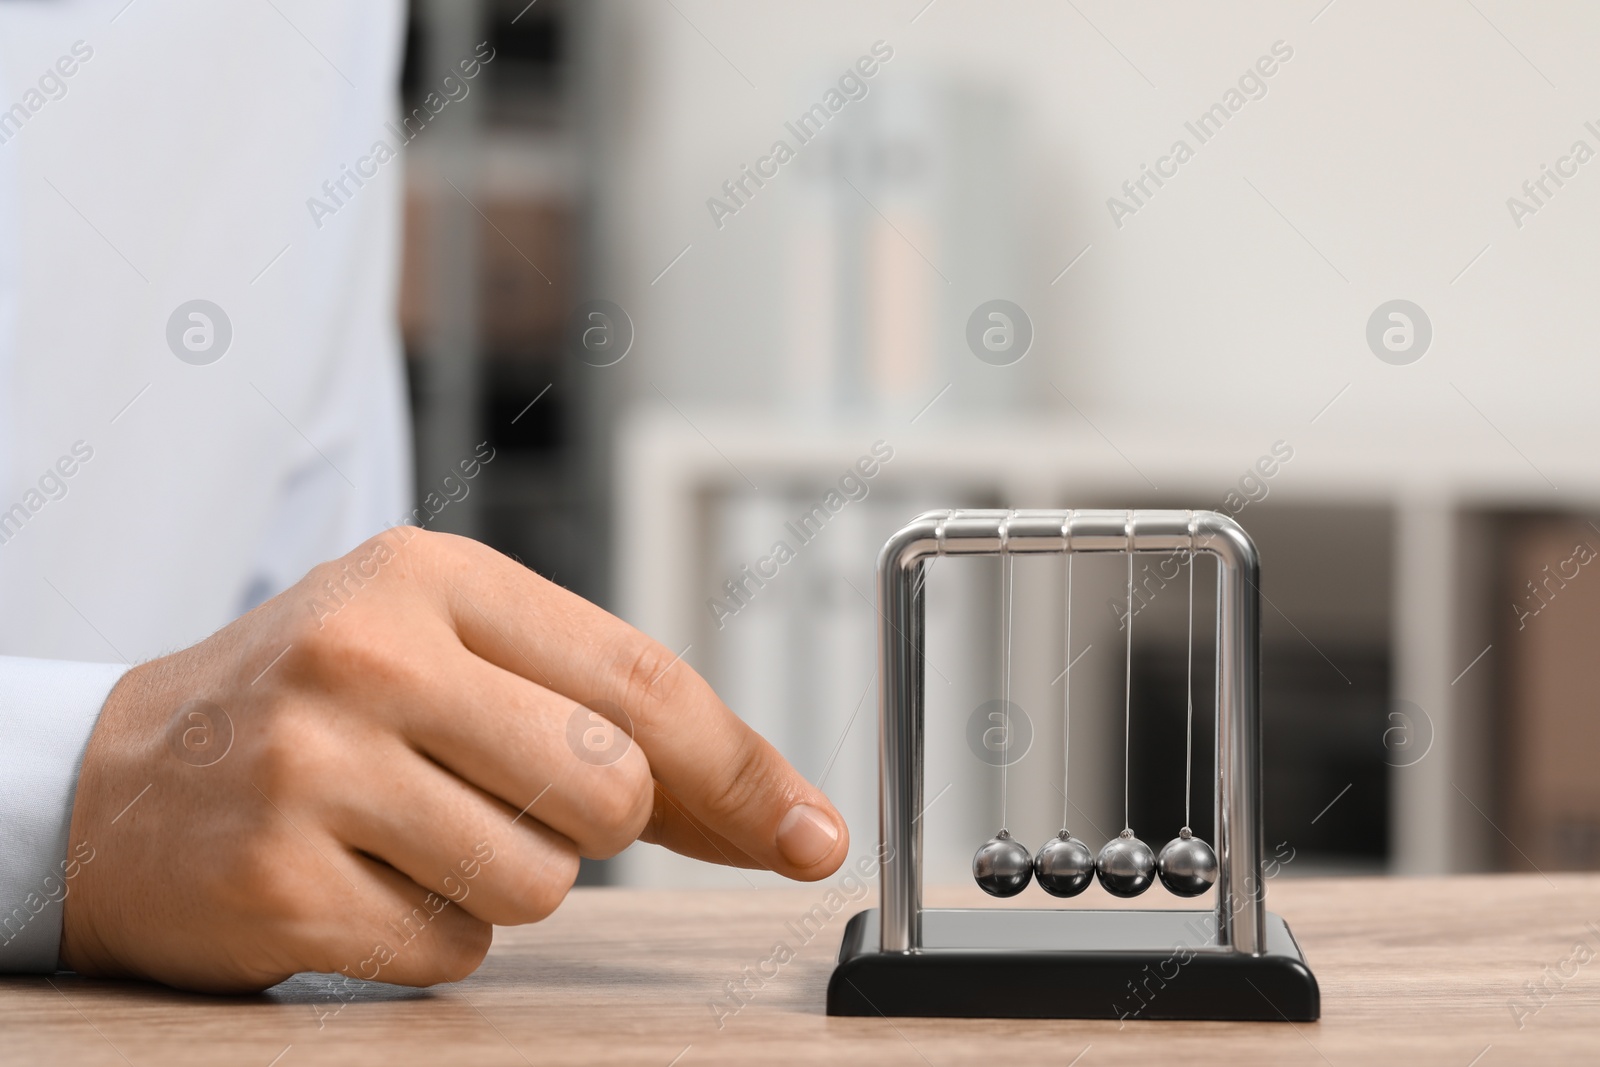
[{"x1": 603, "y1": 0, "x2": 1600, "y2": 454}]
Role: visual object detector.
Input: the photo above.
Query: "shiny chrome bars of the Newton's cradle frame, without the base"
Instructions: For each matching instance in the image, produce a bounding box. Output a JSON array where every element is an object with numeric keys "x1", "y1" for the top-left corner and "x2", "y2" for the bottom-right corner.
[{"x1": 877, "y1": 510, "x2": 1266, "y2": 955}]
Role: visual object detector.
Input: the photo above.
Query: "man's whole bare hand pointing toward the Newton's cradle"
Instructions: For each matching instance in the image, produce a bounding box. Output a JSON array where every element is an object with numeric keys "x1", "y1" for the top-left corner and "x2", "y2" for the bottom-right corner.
[{"x1": 61, "y1": 526, "x2": 850, "y2": 990}]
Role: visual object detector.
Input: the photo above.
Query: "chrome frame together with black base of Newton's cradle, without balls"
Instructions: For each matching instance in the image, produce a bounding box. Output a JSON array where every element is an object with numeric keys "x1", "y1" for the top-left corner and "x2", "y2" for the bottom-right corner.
[{"x1": 827, "y1": 510, "x2": 1320, "y2": 1022}]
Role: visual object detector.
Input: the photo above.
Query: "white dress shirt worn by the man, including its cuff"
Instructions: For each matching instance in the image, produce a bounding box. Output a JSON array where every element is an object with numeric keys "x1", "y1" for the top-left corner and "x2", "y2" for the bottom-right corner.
[{"x1": 0, "y1": 0, "x2": 411, "y2": 971}]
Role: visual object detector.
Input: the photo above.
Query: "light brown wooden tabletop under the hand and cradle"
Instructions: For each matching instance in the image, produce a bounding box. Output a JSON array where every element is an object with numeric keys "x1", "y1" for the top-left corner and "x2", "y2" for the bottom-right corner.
[{"x1": 0, "y1": 875, "x2": 1600, "y2": 1067}]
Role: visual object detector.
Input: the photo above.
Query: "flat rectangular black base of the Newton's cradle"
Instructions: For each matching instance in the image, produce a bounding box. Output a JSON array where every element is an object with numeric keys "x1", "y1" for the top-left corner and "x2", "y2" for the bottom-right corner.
[{"x1": 827, "y1": 909, "x2": 1322, "y2": 1022}]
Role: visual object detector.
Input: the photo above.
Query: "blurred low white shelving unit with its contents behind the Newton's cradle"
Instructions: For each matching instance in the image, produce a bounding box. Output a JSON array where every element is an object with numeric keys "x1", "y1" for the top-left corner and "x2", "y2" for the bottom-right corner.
[{"x1": 614, "y1": 408, "x2": 1600, "y2": 885}]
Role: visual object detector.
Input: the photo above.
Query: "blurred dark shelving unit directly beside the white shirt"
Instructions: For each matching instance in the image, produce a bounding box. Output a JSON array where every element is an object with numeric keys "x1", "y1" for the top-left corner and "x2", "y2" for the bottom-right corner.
[{"x1": 400, "y1": 0, "x2": 605, "y2": 595}]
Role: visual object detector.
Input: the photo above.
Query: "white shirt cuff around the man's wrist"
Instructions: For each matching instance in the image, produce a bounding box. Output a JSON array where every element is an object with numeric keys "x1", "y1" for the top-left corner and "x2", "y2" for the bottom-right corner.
[{"x1": 0, "y1": 656, "x2": 128, "y2": 973}]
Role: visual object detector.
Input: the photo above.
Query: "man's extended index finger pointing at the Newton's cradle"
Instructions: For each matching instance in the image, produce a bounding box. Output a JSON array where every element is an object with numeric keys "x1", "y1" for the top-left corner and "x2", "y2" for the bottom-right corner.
[{"x1": 434, "y1": 534, "x2": 850, "y2": 880}]
